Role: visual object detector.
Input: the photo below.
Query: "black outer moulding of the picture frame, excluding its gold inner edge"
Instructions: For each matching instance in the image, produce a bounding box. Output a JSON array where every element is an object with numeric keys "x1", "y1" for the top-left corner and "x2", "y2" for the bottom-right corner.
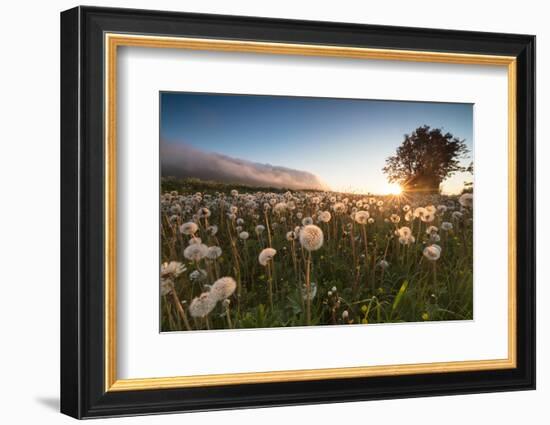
[{"x1": 61, "y1": 7, "x2": 535, "y2": 418}]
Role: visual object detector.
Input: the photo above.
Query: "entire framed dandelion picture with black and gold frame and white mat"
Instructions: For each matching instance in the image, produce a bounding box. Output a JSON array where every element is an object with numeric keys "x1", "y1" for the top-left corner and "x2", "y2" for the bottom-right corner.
[{"x1": 61, "y1": 7, "x2": 535, "y2": 418}]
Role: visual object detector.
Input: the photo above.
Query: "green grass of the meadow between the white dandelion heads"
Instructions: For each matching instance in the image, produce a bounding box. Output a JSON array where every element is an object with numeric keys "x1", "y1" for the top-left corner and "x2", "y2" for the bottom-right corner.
[{"x1": 161, "y1": 179, "x2": 473, "y2": 331}]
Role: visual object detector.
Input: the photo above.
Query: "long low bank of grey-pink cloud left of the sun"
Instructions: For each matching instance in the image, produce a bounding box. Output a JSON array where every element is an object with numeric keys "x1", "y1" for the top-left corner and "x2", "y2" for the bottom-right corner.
[{"x1": 160, "y1": 141, "x2": 329, "y2": 190}]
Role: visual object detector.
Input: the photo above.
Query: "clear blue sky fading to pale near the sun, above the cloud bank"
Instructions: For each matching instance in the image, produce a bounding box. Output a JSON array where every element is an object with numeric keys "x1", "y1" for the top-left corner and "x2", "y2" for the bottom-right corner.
[{"x1": 160, "y1": 92, "x2": 473, "y2": 193}]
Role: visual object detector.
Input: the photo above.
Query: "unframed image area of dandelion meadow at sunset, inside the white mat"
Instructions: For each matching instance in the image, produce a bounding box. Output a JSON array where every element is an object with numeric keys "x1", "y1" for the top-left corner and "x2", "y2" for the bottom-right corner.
[{"x1": 159, "y1": 92, "x2": 474, "y2": 332}]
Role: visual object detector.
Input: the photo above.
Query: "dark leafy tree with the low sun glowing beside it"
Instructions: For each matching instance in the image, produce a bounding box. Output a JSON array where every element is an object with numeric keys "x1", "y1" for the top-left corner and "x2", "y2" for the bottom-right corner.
[{"x1": 382, "y1": 125, "x2": 469, "y2": 193}]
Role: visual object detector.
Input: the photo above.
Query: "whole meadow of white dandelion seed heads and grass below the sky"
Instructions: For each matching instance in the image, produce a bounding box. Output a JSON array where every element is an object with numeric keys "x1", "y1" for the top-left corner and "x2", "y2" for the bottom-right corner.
[{"x1": 160, "y1": 179, "x2": 473, "y2": 331}]
